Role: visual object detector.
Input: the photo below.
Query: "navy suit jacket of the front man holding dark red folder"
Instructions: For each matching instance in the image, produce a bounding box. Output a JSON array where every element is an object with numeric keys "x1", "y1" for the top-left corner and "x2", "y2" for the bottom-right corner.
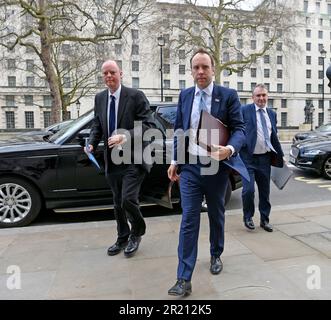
[{"x1": 173, "y1": 84, "x2": 249, "y2": 180}]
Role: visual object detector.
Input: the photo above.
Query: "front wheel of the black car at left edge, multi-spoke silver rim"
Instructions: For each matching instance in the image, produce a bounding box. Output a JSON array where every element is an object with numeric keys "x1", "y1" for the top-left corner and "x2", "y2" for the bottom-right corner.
[{"x1": 0, "y1": 177, "x2": 41, "y2": 228}]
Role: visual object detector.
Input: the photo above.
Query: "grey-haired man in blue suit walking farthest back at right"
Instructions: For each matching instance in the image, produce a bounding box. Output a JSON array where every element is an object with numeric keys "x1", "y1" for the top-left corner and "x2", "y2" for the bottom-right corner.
[{"x1": 240, "y1": 84, "x2": 284, "y2": 232}]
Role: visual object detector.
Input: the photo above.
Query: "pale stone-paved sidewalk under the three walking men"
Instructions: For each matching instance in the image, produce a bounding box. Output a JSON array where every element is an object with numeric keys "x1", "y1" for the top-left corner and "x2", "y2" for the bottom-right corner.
[{"x1": 0, "y1": 201, "x2": 331, "y2": 300}]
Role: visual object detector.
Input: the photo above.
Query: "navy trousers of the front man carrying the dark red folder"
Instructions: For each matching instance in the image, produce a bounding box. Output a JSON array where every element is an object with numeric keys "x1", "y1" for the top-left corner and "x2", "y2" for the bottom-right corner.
[{"x1": 177, "y1": 163, "x2": 229, "y2": 280}]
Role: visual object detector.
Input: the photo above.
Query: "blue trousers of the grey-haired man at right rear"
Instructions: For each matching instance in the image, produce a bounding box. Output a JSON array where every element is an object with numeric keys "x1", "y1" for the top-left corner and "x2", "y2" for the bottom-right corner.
[{"x1": 242, "y1": 152, "x2": 271, "y2": 222}]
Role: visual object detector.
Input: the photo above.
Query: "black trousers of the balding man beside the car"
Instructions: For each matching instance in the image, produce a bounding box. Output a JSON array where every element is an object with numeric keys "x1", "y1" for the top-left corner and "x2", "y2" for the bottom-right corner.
[{"x1": 106, "y1": 164, "x2": 146, "y2": 242}]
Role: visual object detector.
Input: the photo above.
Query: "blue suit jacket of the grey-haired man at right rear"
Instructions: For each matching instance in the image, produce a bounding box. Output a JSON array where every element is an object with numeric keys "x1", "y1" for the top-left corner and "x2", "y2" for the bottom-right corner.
[{"x1": 240, "y1": 103, "x2": 284, "y2": 167}]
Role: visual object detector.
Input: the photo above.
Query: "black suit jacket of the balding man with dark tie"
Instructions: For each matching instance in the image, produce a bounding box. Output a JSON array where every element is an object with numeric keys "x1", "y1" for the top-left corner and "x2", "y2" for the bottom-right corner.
[{"x1": 89, "y1": 85, "x2": 155, "y2": 174}]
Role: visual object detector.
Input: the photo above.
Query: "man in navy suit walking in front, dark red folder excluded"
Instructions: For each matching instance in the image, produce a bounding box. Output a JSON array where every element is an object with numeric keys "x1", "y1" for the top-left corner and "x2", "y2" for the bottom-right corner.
[{"x1": 168, "y1": 49, "x2": 247, "y2": 296}]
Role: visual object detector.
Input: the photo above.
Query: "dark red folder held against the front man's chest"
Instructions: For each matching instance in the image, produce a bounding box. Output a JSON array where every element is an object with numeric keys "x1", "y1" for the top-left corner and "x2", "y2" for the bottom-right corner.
[{"x1": 197, "y1": 111, "x2": 230, "y2": 152}]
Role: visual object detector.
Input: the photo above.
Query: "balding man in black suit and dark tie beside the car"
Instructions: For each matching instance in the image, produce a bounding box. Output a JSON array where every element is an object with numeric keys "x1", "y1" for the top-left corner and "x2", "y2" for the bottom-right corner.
[{"x1": 88, "y1": 60, "x2": 155, "y2": 257}]
